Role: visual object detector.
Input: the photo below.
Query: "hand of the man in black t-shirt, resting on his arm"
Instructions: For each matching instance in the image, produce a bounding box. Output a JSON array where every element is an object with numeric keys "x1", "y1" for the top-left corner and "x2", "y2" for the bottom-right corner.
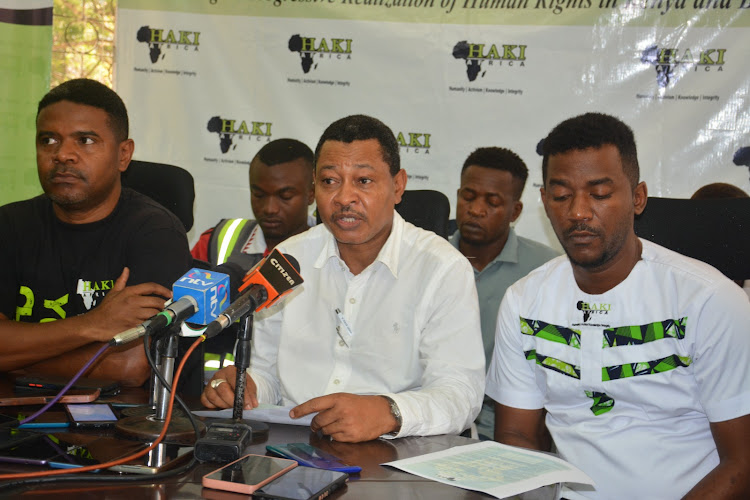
[{"x1": 83, "y1": 267, "x2": 172, "y2": 342}]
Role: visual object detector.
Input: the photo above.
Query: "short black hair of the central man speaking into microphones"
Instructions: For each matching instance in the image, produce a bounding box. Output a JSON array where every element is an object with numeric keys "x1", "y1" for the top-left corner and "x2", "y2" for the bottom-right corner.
[{"x1": 315, "y1": 115, "x2": 401, "y2": 176}]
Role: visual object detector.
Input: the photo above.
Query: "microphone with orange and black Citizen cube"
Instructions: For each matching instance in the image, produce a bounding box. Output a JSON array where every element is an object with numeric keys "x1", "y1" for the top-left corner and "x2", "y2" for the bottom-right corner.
[{"x1": 203, "y1": 249, "x2": 304, "y2": 339}]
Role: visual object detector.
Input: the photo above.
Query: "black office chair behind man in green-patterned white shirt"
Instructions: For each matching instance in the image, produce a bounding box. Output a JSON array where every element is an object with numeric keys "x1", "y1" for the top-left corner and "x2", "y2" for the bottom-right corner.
[{"x1": 635, "y1": 198, "x2": 750, "y2": 280}]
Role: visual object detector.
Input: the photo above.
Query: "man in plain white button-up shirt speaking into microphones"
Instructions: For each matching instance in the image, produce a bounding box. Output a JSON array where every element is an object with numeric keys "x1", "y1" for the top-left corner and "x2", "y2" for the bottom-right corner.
[{"x1": 201, "y1": 115, "x2": 484, "y2": 442}]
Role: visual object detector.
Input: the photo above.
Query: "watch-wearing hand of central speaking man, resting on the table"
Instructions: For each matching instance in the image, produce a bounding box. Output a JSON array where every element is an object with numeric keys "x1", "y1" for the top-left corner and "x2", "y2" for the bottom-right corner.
[{"x1": 292, "y1": 392, "x2": 398, "y2": 443}]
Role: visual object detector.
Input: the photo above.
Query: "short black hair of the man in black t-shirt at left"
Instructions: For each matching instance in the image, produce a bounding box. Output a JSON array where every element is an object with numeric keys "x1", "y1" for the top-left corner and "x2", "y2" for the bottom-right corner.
[{"x1": 36, "y1": 78, "x2": 129, "y2": 142}]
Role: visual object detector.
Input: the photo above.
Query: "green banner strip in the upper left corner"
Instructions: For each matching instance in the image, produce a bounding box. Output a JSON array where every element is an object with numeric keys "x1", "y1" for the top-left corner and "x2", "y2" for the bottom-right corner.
[{"x1": 0, "y1": 0, "x2": 52, "y2": 205}]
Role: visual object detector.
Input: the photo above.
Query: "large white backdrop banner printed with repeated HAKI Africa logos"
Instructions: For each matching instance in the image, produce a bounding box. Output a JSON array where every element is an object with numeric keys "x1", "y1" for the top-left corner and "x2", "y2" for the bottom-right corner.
[{"x1": 116, "y1": 0, "x2": 750, "y2": 248}]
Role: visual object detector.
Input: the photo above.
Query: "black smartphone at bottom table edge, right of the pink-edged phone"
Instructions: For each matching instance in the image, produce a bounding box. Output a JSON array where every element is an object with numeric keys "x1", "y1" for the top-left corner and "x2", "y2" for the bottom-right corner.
[{"x1": 253, "y1": 467, "x2": 349, "y2": 500}]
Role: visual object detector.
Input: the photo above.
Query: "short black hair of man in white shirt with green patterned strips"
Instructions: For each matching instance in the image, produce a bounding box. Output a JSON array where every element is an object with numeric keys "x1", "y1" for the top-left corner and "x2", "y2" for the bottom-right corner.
[{"x1": 541, "y1": 113, "x2": 640, "y2": 189}]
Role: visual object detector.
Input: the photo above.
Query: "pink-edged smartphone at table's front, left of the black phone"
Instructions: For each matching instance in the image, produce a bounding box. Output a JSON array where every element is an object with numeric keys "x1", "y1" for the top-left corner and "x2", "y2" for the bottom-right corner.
[{"x1": 203, "y1": 455, "x2": 297, "y2": 495}]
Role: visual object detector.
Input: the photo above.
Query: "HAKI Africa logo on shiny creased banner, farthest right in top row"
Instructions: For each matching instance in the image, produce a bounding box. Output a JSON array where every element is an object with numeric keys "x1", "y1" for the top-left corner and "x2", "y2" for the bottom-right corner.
[{"x1": 641, "y1": 45, "x2": 727, "y2": 88}]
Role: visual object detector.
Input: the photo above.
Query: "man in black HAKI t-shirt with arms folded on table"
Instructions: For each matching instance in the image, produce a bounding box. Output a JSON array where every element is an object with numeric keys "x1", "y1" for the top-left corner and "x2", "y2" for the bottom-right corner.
[{"x1": 0, "y1": 79, "x2": 192, "y2": 385}]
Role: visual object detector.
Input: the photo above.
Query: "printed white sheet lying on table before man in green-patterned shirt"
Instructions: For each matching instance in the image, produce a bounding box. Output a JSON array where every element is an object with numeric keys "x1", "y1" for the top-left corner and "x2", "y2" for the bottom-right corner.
[{"x1": 382, "y1": 441, "x2": 594, "y2": 498}]
